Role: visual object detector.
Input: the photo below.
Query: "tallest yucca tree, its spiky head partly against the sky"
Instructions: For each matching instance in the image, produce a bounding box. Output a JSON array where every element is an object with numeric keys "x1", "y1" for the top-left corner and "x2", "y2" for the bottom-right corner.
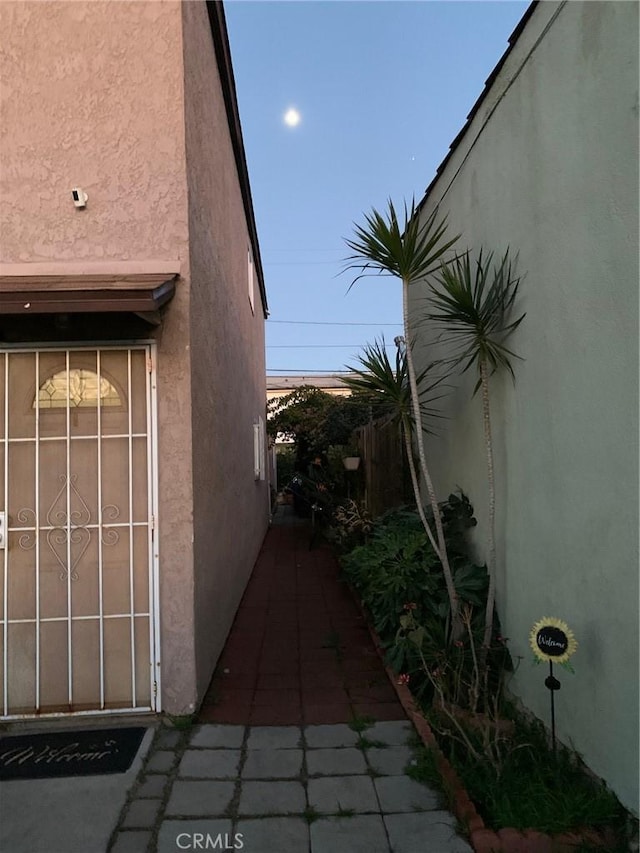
[{"x1": 345, "y1": 199, "x2": 459, "y2": 632}]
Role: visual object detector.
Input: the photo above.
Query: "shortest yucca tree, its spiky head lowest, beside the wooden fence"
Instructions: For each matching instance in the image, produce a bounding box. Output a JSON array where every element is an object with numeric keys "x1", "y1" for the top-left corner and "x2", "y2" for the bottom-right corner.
[{"x1": 343, "y1": 338, "x2": 444, "y2": 553}]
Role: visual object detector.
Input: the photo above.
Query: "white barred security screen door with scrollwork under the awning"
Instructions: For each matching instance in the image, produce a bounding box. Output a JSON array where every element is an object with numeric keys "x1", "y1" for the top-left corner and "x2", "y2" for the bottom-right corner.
[{"x1": 0, "y1": 346, "x2": 157, "y2": 717}]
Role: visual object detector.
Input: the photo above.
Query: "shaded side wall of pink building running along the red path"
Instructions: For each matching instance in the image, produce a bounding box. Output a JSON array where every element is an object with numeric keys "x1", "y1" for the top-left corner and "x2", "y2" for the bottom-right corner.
[{"x1": 183, "y1": 2, "x2": 269, "y2": 696}]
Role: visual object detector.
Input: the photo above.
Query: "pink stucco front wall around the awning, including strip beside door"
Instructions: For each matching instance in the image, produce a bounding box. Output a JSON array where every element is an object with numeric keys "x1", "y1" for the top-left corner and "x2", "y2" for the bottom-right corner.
[{"x1": 0, "y1": 0, "x2": 196, "y2": 710}]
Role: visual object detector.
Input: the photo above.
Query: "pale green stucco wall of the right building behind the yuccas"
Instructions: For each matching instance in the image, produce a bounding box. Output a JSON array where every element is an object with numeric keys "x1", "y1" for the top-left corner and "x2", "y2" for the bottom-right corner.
[{"x1": 411, "y1": 2, "x2": 638, "y2": 810}]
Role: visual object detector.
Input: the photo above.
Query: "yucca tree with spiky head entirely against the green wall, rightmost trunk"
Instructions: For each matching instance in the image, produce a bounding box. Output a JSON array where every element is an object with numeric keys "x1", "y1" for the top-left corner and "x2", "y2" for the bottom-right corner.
[{"x1": 426, "y1": 249, "x2": 525, "y2": 665}]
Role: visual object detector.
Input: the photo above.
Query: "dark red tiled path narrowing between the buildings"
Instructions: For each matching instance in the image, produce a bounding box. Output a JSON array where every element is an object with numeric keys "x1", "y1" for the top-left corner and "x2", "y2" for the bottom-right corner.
[{"x1": 199, "y1": 506, "x2": 405, "y2": 725}]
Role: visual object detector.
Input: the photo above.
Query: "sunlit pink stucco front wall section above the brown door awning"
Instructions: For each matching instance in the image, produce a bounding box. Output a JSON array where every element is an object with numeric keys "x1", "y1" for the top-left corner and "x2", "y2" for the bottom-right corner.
[{"x1": 0, "y1": 0, "x2": 187, "y2": 263}]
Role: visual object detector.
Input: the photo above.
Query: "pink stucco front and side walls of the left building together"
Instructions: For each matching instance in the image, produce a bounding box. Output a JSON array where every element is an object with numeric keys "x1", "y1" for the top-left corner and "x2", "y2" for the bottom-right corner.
[{"x1": 0, "y1": 0, "x2": 268, "y2": 713}]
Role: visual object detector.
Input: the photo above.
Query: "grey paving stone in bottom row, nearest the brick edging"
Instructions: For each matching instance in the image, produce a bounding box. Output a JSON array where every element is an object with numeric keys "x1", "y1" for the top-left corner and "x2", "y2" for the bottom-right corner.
[{"x1": 384, "y1": 811, "x2": 473, "y2": 853}]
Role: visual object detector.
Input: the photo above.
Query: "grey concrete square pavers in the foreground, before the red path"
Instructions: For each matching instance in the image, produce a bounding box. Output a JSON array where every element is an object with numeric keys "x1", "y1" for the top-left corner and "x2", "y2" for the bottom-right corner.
[{"x1": 112, "y1": 721, "x2": 471, "y2": 853}]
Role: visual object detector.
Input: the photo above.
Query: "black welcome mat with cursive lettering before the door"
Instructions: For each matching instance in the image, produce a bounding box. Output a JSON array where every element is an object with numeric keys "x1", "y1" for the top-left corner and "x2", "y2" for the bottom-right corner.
[{"x1": 0, "y1": 727, "x2": 146, "y2": 780}]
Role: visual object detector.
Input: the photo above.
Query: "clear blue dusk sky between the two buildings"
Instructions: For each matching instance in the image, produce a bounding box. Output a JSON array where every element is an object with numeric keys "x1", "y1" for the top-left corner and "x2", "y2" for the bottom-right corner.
[{"x1": 225, "y1": 0, "x2": 529, "y2": 375}]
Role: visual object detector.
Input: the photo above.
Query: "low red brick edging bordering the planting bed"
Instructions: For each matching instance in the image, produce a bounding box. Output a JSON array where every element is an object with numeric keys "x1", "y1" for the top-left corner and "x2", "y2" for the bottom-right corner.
[{"x1": 347, "y1": 583, "x2": 614, "y2": 853}]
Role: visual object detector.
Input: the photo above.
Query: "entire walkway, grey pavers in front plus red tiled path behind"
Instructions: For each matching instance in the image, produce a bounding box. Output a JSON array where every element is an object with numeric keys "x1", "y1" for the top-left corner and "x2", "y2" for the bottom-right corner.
[{"x1": 110, "y1": 508, "x2": 471, "y2": 853}]
